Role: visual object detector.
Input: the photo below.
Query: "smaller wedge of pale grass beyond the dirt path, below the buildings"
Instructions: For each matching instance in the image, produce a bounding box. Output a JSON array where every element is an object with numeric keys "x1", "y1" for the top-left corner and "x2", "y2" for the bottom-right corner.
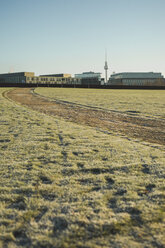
[{"x1": 35, "y1": 88, "x2": 165, "y2": 119}]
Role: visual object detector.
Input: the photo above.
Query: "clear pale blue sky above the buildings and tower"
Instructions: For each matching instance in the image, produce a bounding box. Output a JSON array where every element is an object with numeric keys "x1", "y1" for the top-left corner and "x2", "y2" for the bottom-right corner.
[{"x1": 0, "y1": 0, "x2": 165, "y2": 76}]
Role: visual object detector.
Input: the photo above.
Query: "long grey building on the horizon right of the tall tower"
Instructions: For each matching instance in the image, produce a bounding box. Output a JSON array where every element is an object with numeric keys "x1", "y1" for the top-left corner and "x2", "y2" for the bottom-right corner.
[{"x1": 108, "y1": 72, "x2": 165, "y2": 86}]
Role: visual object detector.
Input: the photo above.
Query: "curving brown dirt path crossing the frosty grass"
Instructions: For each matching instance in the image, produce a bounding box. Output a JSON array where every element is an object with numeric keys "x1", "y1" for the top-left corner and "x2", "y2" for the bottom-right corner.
[{"x1": 4, "y1": 88, "x2": 165, "y2": 145}]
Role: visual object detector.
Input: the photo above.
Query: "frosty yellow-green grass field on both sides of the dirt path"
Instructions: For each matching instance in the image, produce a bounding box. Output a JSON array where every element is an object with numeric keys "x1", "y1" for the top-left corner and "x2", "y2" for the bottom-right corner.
[{"x1": 0, "y1": 88, "x2": 165, "y2": 248}]
